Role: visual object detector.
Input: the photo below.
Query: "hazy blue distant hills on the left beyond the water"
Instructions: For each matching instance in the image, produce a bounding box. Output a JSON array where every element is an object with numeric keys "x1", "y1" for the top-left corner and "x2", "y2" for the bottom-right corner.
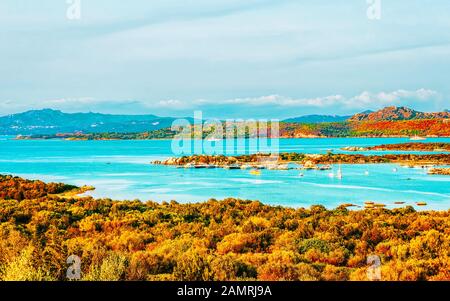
[{"x1": 0, "y1": 109, "x2": 186, "y2": 135}]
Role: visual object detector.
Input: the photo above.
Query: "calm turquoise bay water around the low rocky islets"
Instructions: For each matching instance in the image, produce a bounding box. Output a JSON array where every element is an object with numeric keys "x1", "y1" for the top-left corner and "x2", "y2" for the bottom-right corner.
[{"x1": 0, "y1": 137, "x2": 450, "y2": 209}]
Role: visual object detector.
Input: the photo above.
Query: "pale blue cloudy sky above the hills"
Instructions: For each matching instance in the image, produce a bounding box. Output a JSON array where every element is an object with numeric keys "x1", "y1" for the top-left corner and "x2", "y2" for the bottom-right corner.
[{"x1": 0, "y1": 0, "x2": 450, "y2": 118}]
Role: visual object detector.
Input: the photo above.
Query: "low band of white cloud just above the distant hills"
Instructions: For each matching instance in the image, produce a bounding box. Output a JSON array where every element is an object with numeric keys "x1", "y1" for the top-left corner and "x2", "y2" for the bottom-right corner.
[{"x1": 0, "y1": 88, "x2": 446, "y2": 118}]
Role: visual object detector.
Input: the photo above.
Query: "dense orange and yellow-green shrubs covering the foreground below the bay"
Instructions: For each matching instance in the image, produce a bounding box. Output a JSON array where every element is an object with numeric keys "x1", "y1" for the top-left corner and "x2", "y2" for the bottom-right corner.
[{"x1": 0, "y1": 177, "x2": 450, "y2": 280}]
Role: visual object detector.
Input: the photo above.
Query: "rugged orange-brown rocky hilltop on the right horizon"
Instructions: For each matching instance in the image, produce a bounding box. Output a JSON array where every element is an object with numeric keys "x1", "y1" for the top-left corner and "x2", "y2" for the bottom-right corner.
[{"x1": 348, "y1": 107, "x2": 450, "y2": 122}]
